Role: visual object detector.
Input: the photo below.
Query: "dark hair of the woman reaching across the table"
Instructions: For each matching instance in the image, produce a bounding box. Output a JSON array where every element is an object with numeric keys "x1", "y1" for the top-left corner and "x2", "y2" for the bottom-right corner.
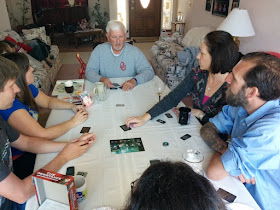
[{"x1": 204, "y1": 31, "x2": 239, "y2": 74}]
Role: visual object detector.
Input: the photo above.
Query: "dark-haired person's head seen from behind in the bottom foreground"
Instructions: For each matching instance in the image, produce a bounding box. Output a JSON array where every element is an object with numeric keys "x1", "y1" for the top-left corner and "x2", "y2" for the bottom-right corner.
[{"x1": 124, "y1": 162, "x2": 226, "y2": 210}]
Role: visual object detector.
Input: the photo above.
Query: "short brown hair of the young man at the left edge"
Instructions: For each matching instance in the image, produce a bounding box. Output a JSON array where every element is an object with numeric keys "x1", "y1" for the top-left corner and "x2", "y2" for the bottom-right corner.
[{"x1": 0, "y1": 56, "x2": 19, "y2": 92}]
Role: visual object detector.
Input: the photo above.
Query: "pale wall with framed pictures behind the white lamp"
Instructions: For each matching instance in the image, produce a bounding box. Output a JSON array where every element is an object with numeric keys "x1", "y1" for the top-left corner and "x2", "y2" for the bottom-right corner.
[{"x1": 180, "y1": 0, "x2": 280, "y2": 53}]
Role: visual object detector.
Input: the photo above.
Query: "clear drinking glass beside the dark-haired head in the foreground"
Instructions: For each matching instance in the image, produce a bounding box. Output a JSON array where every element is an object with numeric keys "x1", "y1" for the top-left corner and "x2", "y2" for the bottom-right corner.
[{"x1": 182, "y1": 149, "x2": 204, "y2": 176}]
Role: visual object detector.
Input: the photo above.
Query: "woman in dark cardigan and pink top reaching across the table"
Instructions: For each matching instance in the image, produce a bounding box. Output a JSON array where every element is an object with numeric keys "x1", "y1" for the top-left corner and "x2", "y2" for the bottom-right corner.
[{"x1": 126, "y1": 31, "x2": 239, "y2": 127}]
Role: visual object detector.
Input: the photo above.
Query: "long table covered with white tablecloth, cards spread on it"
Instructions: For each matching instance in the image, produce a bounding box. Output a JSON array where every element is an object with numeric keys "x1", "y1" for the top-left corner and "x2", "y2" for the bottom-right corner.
[{"x1": 26, "y1": 76, "x2": 259, "y2": 210}]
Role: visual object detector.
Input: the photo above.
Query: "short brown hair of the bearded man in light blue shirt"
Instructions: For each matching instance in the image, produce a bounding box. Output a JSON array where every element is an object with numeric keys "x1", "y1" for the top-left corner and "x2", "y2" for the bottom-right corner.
[{"x1": 241, "y1": 52, "x2": 280, "y2": 101}]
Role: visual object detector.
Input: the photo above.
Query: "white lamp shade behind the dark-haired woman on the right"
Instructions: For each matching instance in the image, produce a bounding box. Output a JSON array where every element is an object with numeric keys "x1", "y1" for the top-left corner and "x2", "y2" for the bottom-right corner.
[{"x1": 217, "y1": 8, "x2": 255, "y2": 37}]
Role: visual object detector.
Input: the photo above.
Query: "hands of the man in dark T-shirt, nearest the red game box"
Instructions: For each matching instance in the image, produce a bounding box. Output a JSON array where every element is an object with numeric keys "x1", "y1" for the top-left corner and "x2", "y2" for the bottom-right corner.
[{"x1": 58, "y1": 133, "x2": 96, "y2": 161}]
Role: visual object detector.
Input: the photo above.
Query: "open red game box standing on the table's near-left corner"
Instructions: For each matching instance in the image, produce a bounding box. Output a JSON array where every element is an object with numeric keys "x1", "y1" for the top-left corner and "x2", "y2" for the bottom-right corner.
[{"x1": 32, "y1": 169, "x2": 78, "y2": 210}]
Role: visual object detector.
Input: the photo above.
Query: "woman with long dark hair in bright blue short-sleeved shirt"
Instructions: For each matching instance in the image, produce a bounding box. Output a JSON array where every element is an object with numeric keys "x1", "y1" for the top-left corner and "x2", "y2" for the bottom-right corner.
[{"x1": 0, "y1": 53, "x2": 88, "y2": 178}]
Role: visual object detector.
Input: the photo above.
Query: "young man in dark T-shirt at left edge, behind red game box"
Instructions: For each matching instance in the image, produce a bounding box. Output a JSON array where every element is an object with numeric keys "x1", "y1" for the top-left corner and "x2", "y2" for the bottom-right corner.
[{"x1": 0, "y1": 56, "x2": 96, "y2": 210}]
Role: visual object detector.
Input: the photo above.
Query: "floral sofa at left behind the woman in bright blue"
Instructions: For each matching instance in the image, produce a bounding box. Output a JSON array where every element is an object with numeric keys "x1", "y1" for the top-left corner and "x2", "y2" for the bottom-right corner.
[{"x1": 0, "y1": 27, "x2": 61, "y2": 94}]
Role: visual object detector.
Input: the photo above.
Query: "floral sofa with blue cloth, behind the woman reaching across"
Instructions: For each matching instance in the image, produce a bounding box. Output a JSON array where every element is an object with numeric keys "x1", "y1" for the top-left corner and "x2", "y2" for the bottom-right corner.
[{"x1": 151, "y1": 27, "x2": 214, "y2": 90}]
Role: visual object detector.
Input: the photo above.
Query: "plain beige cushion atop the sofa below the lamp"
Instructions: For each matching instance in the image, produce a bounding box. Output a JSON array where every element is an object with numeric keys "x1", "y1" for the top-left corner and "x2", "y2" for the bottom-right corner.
[{"x1": 181, "y1": 26, "x2": 214, "y2": 47}]
